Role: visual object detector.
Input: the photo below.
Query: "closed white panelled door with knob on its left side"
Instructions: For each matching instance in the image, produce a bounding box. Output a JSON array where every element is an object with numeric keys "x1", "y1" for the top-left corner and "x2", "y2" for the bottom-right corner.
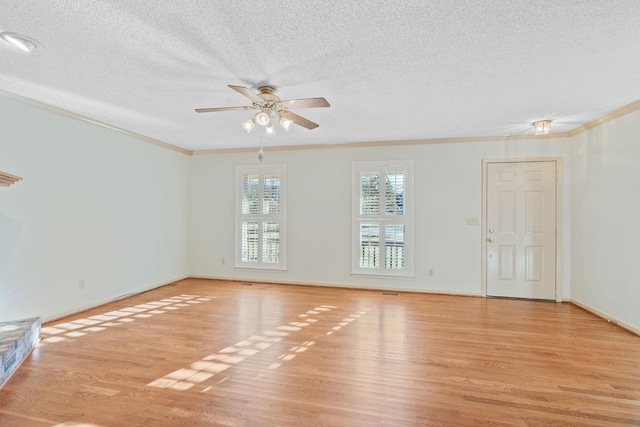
[{"x1": 484, "y1": 161, "x2": 556, "y2": 300}]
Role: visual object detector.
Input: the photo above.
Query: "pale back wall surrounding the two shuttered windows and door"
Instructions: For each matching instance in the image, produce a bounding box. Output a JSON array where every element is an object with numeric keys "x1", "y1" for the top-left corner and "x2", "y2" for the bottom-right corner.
[{"x1": 190, "y1": 138, "x2": 571, "y2": 299}]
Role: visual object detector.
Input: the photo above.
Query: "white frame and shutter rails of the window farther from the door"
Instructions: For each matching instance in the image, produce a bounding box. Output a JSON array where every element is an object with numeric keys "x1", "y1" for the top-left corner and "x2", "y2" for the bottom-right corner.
[{"x1": 235, "y1": 165, "x2": 287, "y2": 270}]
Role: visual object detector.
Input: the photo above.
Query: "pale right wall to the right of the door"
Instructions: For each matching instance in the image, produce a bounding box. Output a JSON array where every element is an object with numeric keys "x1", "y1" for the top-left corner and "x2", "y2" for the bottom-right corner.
[{"x1": 571, "y1": 111, "x2": 640, "y2": 331}]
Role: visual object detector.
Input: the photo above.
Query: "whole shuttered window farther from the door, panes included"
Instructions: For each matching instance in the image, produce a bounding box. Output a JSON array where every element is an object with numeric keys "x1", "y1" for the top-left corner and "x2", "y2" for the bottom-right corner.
[{"x1": 236, "y1": 165, "x2": 286, "y2": 270}]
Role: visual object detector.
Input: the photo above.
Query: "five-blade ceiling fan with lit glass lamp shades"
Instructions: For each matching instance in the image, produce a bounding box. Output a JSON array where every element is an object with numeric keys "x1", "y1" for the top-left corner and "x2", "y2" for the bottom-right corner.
[{"x1": 195, "y1": 85, "x2": 330, "y2": 136}]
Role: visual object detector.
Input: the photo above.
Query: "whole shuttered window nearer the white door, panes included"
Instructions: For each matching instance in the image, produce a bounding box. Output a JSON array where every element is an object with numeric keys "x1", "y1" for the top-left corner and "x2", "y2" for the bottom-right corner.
[{"x1": 352, "y1": 161, "x2": 413, "y2": 276}]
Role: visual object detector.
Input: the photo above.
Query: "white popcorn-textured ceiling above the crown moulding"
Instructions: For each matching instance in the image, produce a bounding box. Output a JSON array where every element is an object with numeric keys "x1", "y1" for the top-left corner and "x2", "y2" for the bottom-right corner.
[{"x1": 0, "y1": 0, "x2": 640, "y2": 150}]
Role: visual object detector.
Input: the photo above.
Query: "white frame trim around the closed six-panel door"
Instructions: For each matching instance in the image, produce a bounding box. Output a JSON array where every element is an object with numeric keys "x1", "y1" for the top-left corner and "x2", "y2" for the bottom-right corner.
[{"x1": 481, "y1": 157, "x2": 562, "y2": 302}]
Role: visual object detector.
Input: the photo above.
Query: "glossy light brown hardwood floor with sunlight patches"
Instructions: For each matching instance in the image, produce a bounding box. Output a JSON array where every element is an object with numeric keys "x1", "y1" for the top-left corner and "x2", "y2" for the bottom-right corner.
[{"x1": 0, "y1": 279, "x2": 640, "y2": 427}]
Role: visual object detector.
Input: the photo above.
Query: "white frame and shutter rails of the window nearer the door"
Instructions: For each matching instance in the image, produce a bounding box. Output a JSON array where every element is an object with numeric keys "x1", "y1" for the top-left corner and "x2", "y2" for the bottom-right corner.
[{"x1": 351, "y1": 160, "x2": 414, "y2": 277}]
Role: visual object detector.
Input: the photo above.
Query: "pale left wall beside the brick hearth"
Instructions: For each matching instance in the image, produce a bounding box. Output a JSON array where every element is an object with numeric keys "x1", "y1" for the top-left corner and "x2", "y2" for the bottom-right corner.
[{"x1": 0, "y1": 96, "x2": 189, "y2": 321}]
